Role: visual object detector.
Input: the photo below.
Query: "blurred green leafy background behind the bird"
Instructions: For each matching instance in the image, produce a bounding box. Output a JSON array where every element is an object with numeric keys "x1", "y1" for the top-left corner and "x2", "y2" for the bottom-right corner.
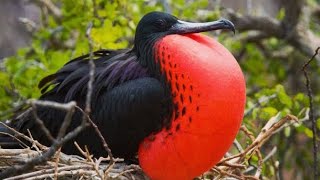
[{"x1": 0, "y1": 0, "x2": 320, "y2": 179}]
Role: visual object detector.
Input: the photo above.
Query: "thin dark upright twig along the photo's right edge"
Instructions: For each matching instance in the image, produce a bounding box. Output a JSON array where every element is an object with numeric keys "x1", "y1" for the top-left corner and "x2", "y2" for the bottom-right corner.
[{"x1": 302, "y1": 47, "x2": 320, "y2": 180}]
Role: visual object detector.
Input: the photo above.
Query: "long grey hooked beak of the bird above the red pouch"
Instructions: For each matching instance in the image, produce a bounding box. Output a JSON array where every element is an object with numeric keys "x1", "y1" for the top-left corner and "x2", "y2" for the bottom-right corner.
[{"x1": 169, "y1": 19, "x2": 235, "y2": 34}]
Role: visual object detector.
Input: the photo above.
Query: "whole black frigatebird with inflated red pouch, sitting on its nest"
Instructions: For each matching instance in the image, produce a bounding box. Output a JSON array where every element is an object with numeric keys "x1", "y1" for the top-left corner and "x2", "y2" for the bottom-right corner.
[{"x1": 0, "y1": 12, "x2": 245, "y2": 179}]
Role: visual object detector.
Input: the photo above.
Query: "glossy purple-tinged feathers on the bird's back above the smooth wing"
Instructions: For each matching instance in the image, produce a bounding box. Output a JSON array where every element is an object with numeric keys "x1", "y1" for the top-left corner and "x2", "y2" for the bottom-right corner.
[{"x1": 39, "y1": 50, "x2": 148, "y2": 102}]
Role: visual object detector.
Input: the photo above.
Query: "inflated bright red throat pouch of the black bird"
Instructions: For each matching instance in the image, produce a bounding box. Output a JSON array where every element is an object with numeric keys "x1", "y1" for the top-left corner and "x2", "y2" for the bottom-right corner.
[{"x1": 138, "y1": 34, "x2": 245, "y2": 180}]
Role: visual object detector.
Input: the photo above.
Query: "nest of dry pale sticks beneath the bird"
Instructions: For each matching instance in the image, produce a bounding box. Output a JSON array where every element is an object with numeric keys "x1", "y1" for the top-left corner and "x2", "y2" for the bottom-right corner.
[{"x1": 0, "y1": 112, "x2": 297, "y2": 180}]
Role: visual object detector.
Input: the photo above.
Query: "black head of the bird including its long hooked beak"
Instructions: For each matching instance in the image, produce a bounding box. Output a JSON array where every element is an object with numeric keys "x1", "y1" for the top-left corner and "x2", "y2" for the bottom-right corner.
[{"x1": 134, "y1": 12, "x2": 235, "y2": 65}]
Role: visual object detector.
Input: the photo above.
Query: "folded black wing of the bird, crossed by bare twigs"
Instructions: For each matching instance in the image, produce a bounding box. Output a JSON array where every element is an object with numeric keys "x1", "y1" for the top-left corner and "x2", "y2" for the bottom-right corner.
[{"x1": 0, "y1": 49, "x2": 172, "y2": 157}]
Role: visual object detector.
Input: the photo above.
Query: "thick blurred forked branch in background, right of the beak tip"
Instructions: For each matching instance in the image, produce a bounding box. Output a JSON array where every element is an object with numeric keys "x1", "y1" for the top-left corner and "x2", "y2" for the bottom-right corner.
[{"x1": 225, "y1": 0, "x2": 320, "y2": 62}]
